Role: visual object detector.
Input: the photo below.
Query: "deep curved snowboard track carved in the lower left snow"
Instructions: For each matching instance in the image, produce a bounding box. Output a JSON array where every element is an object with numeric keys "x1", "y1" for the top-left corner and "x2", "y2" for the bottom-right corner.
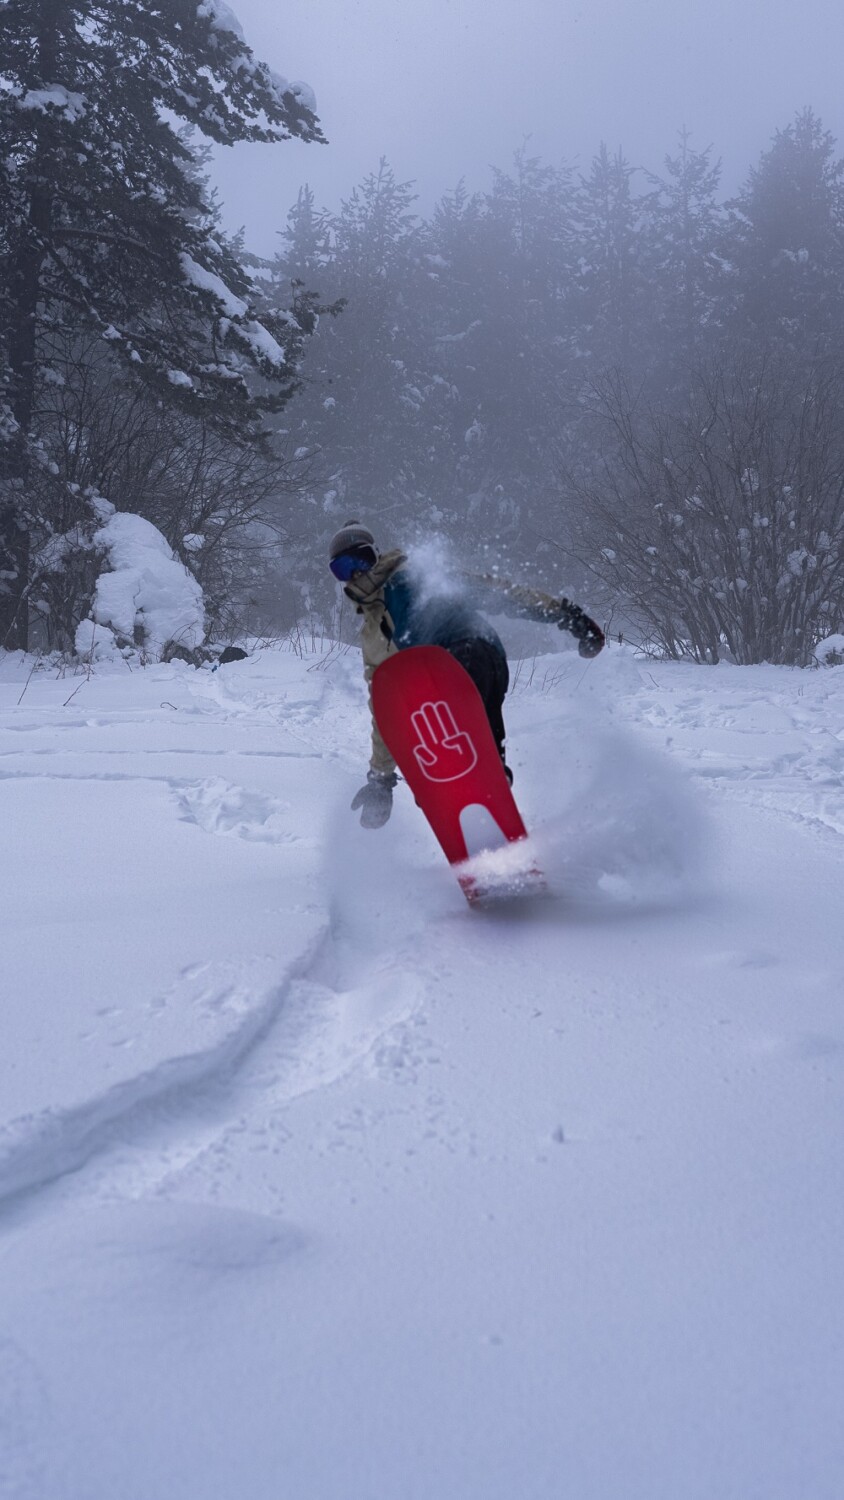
[{"x1": 0, "y1": 929, "x2": 434, "y2": 1218}]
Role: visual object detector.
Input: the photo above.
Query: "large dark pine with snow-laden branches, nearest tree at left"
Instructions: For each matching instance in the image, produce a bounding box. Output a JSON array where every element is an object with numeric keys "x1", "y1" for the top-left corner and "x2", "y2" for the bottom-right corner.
[{"x1": 0, "y1": 0, "x2": 322, "y2": 647}]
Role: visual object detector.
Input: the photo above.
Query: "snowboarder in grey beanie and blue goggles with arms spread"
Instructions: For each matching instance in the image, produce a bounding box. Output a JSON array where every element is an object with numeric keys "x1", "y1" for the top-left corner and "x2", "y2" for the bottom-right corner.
[{"x1": 328, "y1": 521, "x2": 604, "y2": 828}]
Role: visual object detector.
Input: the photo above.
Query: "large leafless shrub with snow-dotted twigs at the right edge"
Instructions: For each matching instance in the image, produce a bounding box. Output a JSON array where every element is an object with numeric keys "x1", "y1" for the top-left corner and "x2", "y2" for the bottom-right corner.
[{"x1": 571, "y1": 357, "x2": 844, "y2": 665}]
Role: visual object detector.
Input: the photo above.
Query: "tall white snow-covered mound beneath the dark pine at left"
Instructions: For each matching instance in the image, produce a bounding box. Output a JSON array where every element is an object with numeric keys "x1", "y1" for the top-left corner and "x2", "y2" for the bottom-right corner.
[{"x1": 76, "y1": 513, "x2": 205, "y2": 657}]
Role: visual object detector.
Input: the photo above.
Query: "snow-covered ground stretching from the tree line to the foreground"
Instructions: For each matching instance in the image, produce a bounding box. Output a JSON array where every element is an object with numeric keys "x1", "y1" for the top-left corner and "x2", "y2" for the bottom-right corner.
[{"x1": 0, "y1": 648, "x2": 844, "y2": 1500}]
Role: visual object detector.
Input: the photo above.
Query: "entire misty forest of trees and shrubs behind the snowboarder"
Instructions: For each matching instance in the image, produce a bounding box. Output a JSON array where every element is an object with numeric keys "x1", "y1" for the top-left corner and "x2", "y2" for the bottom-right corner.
[{"x1": 0, "y1": 0, "x2": 844, "y2": 665}]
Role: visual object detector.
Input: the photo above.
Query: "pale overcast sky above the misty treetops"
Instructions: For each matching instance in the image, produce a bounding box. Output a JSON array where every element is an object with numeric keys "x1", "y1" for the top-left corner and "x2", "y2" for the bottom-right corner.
[{"x1": 214, "y1": 0, "x2": 844, "y2": 254}]
